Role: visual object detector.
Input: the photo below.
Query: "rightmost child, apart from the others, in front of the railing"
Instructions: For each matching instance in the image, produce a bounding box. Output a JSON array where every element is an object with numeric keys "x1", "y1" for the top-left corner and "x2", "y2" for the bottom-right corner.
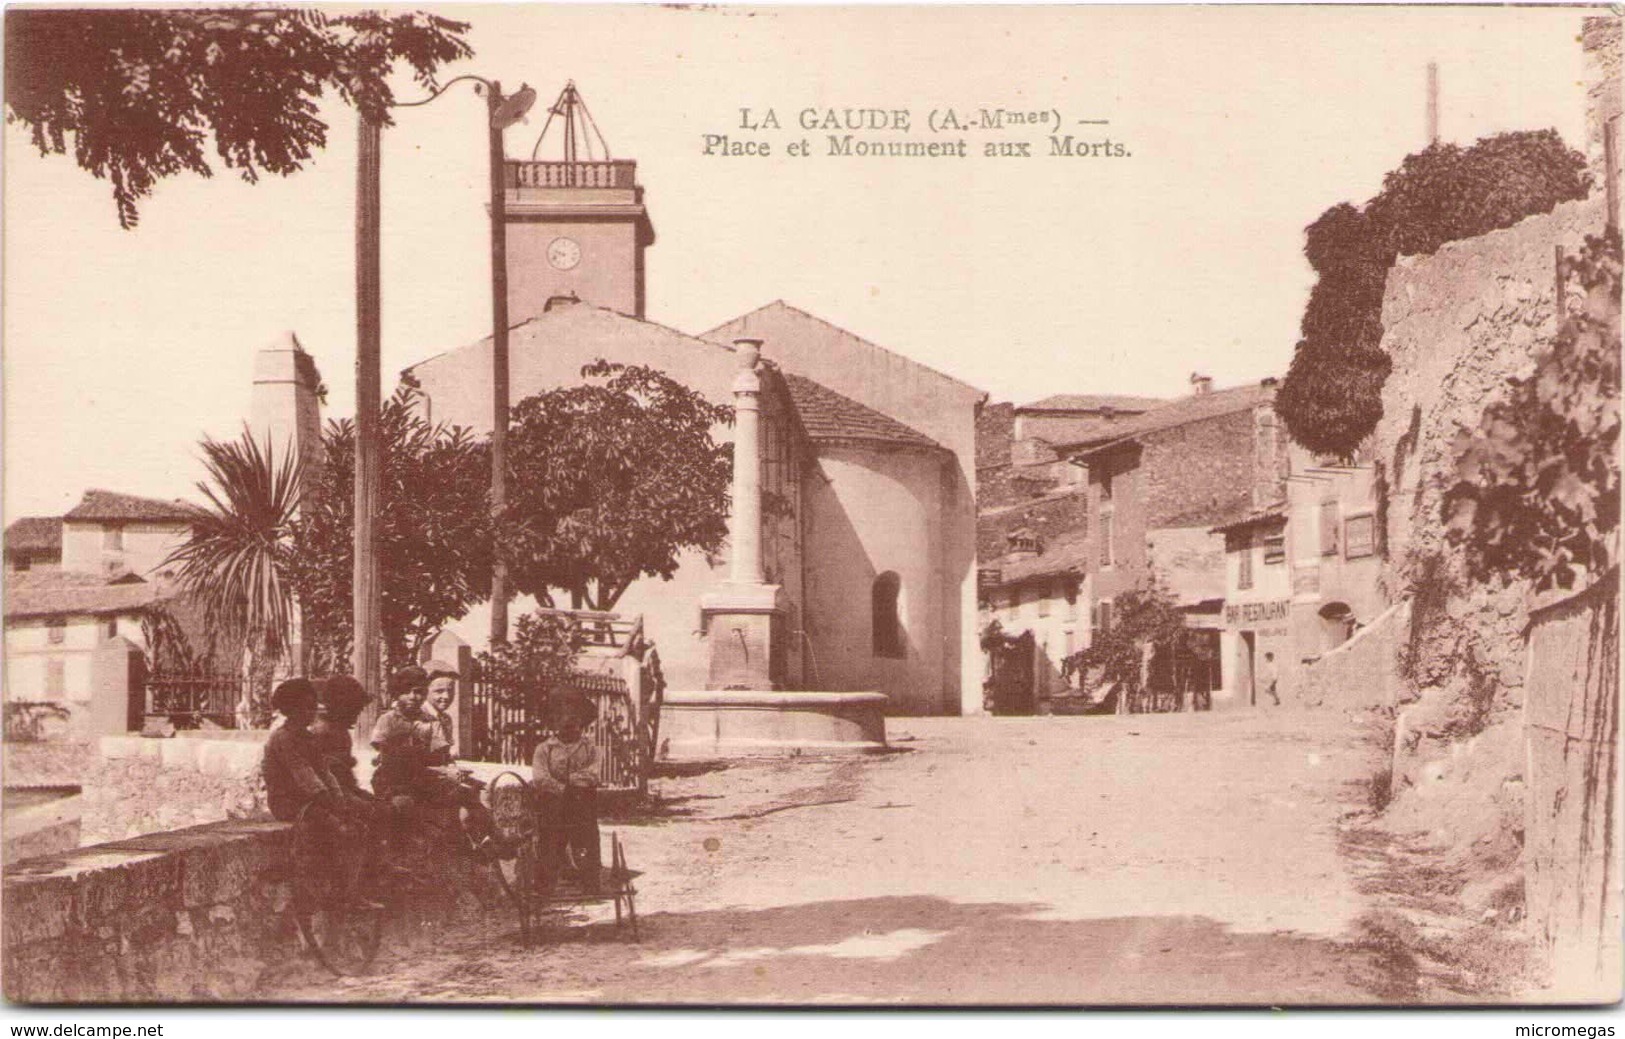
[{"x1": 530, "y1": 711, "x2": 600, "y2": 894}]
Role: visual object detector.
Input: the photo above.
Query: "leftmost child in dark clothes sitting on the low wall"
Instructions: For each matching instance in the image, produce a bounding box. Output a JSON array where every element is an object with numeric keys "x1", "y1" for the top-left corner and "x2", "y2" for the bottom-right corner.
[{"x1": 262, "y1": 678, "x2": 375, "y2": 907}]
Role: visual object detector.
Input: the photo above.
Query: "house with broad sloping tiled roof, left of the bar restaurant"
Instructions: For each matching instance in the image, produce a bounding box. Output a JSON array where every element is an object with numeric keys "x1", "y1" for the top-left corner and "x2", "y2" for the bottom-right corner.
[{"x1": 1071, "y1": 376, "x2": 1289, "y2": 706}]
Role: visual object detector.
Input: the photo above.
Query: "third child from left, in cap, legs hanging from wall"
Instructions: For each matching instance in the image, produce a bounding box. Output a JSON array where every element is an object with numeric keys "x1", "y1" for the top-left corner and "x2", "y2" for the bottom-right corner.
[{"x1": 372, "y1": 667, "x2": 497, "y2": 854}]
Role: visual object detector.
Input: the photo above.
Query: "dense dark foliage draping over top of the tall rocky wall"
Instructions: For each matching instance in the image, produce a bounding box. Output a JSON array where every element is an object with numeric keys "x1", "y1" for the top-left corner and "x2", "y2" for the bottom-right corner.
[{"x1": 1276, "y1": 130, "x2": 1589, "y2": 455}]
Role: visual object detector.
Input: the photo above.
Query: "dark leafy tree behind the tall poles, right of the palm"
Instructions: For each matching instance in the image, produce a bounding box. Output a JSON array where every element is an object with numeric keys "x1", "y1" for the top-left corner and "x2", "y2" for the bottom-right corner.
[{"x1": 289, "y1": 385, "x2": 492, "y2": 672}]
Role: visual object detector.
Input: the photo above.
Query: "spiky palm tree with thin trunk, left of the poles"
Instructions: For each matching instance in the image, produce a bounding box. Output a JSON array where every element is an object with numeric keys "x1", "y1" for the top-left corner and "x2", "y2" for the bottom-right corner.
[{"x1": 164, "y1": 429, "x2": 302, "y2": 727}]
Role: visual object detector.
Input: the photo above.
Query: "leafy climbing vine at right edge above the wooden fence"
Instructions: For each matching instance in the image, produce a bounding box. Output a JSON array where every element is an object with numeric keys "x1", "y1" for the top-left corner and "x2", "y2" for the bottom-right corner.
[{"x1": 1443, "y1": 231, "x2": 1620, "y2": 589}]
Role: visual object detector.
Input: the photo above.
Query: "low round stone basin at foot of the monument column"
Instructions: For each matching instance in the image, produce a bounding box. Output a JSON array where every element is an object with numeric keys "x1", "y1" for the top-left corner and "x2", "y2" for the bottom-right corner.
[{"x1": 658, "y1": 689, "x2": 886, "y2": 761}]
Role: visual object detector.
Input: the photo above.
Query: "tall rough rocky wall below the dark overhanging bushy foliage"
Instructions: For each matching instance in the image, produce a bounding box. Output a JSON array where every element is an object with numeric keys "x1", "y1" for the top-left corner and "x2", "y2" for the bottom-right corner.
[{"x1": 1373, "y1": 198, "x2": 1604, "y2": 779}]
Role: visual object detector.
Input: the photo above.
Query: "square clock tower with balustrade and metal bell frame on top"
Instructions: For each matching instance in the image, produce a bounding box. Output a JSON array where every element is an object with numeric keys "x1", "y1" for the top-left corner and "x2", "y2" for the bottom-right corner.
[{"x1": 504, "y1": 81, "x2": 655, "y2": 324}]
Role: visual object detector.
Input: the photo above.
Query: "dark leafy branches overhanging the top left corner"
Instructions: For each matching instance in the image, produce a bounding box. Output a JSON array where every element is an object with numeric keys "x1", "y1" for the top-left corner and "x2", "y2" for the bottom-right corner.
[{"x1": 5, "y1": 7, "x2": 473, "y2": 228}]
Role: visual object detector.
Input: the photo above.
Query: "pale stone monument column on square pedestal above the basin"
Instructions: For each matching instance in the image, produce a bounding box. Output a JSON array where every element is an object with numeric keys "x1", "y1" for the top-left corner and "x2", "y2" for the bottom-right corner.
[{"x1": 700, "y1": 340, "x2": 785, "y2": 691}]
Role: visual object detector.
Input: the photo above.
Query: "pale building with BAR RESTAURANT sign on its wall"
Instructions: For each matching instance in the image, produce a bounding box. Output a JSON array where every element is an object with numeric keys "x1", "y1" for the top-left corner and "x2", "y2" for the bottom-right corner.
[{"x1": 1214, "y1": 447, "x2": 1388, "y2": 706}]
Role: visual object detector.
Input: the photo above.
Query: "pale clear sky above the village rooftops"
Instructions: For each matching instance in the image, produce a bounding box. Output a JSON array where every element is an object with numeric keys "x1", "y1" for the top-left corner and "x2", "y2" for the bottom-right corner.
[{"x1": 0, "y1": 5, "x2": 1586, "y2": 522}]
